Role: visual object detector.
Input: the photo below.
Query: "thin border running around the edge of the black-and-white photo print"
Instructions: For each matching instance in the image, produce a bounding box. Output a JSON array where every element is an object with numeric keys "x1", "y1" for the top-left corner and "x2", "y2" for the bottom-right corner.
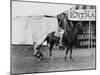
[{"x1": 10, "y1": 0, "x2": 97, "y2": 75}]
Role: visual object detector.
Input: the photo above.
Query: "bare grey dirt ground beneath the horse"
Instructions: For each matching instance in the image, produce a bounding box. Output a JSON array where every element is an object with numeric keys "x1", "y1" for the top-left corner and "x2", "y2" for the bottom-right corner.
[{"x1": 11, "y1": 46, "x2": 95, "y2": 74}]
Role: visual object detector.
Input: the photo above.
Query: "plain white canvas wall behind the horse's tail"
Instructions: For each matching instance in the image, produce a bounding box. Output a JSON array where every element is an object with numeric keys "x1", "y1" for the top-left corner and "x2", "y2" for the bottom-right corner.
[{"x1": 12, "y1": 17, "x2": 58, "y2": 44}]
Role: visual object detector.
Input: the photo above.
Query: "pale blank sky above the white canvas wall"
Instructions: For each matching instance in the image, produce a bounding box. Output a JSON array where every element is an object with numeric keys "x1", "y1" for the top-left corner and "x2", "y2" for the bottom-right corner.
[{"x1": 12, "y1": 1, "x2": 74, "y2": 17}]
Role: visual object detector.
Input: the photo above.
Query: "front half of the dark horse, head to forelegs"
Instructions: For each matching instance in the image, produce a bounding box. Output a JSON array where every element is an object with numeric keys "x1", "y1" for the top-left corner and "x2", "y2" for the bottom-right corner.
[{"x1": 62, "y1": 23, "x2": 84, "y2": 60}]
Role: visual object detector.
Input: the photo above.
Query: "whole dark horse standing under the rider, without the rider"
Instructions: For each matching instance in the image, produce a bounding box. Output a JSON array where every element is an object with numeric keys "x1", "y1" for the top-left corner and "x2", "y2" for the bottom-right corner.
[{"x1": 41, "y1": 23, "x2": 84, "y2": 60}]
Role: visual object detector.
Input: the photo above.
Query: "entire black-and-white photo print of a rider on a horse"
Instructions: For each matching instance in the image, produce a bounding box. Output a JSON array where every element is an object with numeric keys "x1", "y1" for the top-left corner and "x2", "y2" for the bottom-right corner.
[{"x1": 10, "y1": 0, "x2": 96, "y2": 75}]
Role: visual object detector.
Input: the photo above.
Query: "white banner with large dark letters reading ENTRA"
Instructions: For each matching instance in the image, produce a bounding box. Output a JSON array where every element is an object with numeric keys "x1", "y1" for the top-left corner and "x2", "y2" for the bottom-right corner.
[{"x1": 68, "y1": 9, "x2": 96, "y2": 21}]
